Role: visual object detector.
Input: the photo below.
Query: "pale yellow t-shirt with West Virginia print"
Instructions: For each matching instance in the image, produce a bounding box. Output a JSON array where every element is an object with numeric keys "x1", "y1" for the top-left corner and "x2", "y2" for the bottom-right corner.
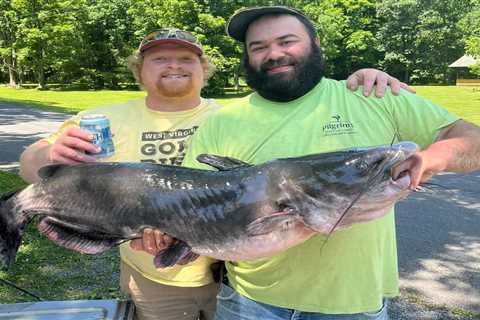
[{"x1": 46, "y1": 99, "x2": 220, "y2": 287}]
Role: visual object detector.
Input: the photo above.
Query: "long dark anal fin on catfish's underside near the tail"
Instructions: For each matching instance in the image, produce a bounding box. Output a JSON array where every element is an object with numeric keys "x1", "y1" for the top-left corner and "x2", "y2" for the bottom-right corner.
[{"x1": 37, "y1": 217, "x2": 121, "y2": 254}]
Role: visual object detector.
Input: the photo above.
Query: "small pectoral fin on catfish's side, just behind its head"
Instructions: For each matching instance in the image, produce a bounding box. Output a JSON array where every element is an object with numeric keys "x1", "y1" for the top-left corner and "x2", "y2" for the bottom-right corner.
[{"x1": 247, "y1": 211, "x2": 298, "y2": 236}]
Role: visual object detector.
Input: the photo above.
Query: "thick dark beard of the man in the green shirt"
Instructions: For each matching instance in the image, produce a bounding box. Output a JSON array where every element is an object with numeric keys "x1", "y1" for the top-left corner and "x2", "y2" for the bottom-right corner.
[{"x1": 243, "y1": 42, "x2": 324, "y2": 102}]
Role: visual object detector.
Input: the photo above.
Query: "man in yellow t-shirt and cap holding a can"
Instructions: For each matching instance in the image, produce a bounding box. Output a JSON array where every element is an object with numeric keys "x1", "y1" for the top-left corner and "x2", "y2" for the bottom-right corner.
[{"x1": 21, "y1": 29, "x2": 416, "y2": 320}]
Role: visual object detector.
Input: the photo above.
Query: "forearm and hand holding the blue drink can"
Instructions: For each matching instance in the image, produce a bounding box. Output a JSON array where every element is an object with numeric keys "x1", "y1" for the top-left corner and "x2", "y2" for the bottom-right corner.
[{"x1": 20, "y1": 128, "x2": 98, "y2": 183}]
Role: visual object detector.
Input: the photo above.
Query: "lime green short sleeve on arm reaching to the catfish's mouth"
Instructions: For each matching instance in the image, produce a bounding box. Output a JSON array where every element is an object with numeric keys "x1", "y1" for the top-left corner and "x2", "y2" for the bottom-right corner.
[{"x1": 385, "y1": 90, "x2": 460, "y2": 149}]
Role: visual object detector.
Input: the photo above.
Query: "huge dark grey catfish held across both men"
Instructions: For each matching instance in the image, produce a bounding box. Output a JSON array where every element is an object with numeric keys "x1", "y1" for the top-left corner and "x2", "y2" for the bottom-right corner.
[{"x1": 0, "y1": 142, "x2": 417, "y2": 267}]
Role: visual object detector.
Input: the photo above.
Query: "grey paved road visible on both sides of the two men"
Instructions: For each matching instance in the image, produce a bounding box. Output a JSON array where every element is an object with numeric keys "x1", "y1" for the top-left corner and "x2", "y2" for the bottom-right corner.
[{"x1": 0, "y1": 102, "x2": 480, "y2": 320}]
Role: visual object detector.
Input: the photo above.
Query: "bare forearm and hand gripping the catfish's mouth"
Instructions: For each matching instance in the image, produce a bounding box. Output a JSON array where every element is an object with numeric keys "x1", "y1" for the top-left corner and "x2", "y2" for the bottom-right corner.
[{"x1": 392, "y1": 120, "x2": 480, "y2": 189}]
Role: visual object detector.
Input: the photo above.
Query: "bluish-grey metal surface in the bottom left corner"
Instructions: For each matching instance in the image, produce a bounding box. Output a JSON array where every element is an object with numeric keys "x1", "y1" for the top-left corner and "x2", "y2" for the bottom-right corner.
[{"x1": 0, "y1": 300, "x2": 134, "y2": 320}]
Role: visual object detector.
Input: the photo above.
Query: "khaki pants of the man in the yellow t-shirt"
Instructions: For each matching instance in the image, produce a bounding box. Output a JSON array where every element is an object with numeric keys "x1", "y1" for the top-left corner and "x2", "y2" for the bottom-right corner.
[{"x1": 120, "y1": 262, "x2": 219, "y2": 320}]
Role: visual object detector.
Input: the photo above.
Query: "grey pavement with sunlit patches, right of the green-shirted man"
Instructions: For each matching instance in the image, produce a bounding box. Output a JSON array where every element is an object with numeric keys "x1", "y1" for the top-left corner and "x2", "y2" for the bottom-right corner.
[{"x1": 396, "y1": 172, "x2": 480, "y2": 313}]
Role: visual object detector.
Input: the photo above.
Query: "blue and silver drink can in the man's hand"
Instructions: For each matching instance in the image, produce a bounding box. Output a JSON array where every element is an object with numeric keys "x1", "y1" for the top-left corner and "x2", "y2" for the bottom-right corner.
[{"x1": 80, "y1": 114, "x2": 115, "y2": 158}]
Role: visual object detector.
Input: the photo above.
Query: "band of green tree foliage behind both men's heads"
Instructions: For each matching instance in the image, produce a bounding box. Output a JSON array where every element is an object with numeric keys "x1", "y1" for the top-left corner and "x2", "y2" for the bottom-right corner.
[{"x1": 0, "y1": 0, "x2": 480, "y2": 88}]
